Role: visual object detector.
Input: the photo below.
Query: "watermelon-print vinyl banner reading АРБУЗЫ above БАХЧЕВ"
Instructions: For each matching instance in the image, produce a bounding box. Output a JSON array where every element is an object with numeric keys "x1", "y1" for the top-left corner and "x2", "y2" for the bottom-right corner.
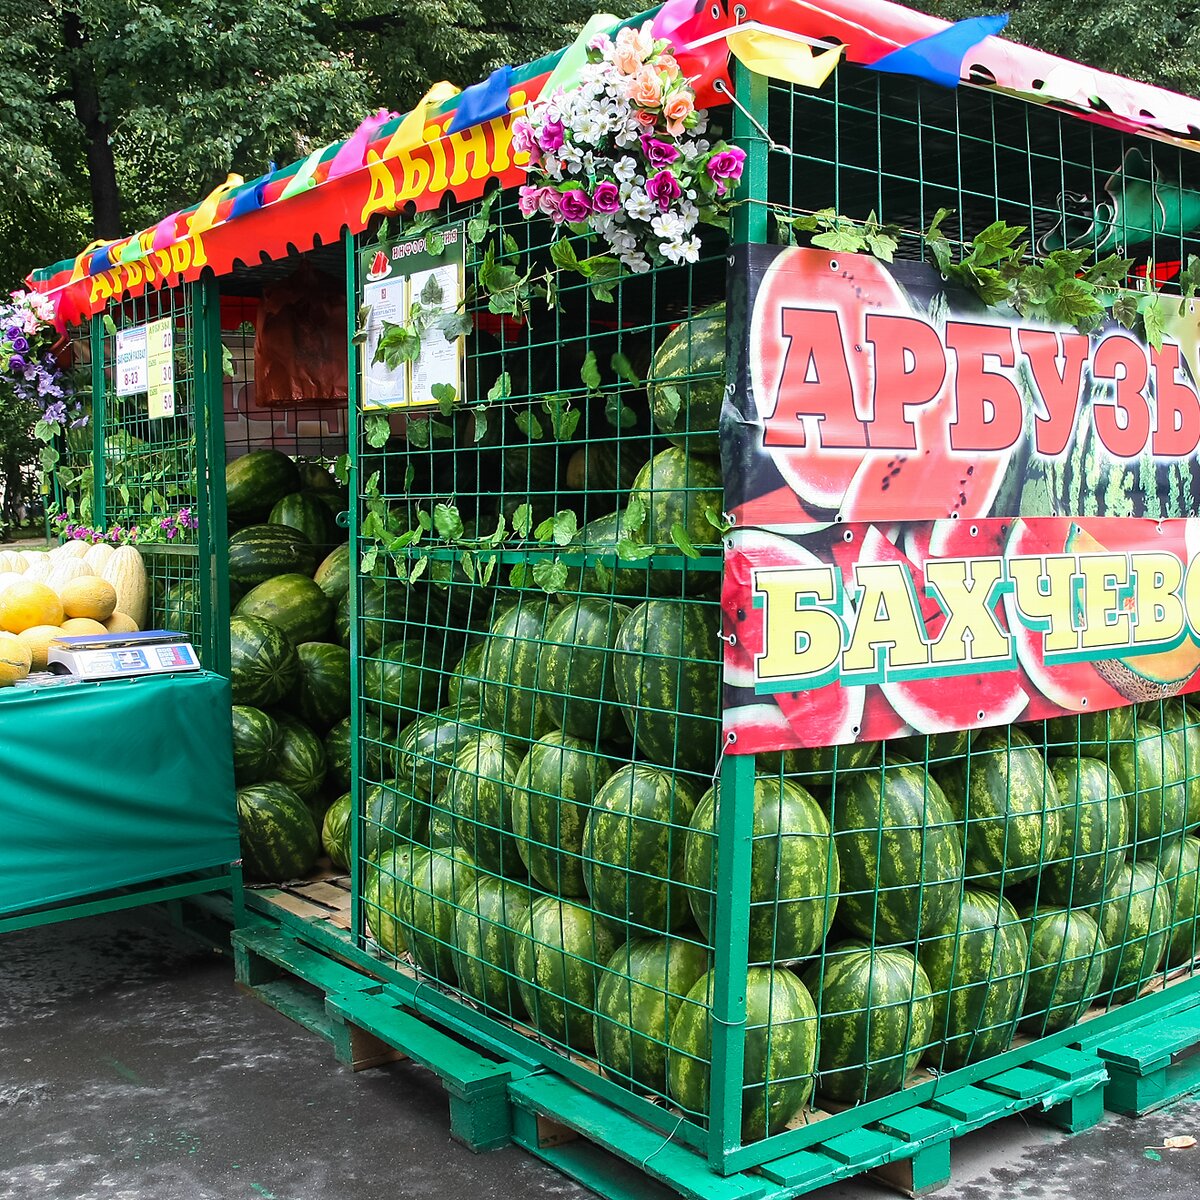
[{"x1": 721, "y1": 246, "x2": 1200, "y2": 754}]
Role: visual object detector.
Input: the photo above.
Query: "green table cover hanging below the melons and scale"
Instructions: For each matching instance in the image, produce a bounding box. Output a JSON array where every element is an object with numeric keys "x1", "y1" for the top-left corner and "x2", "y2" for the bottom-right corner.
[{"x1": 0, "y1": 671, "x2": 240, "y2": 913}]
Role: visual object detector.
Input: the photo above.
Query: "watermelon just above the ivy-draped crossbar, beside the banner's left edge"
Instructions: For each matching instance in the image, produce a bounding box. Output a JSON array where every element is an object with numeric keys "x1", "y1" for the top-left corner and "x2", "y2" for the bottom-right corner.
[{"x1": 629, "y1": 446, "x2": 725, "y2": 566}]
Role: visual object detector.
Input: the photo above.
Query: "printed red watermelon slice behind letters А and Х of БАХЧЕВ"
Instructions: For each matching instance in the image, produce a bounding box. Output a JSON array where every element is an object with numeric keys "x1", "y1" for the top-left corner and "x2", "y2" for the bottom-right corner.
[{"x1": 859, "y1": 526, "x2": 1030, "y2": 733}]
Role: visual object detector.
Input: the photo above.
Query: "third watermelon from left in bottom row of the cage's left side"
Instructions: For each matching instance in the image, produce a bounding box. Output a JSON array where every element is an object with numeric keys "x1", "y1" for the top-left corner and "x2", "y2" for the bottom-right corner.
[{"x1": 451, "y1": 875, "x2": 533, "y2": 1015}]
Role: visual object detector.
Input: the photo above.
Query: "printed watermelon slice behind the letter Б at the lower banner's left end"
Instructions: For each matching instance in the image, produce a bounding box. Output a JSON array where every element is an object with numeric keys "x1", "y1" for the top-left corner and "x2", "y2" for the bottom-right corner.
[{"x1": 722, "y1": 529, "x2": 865, "y2": 754}]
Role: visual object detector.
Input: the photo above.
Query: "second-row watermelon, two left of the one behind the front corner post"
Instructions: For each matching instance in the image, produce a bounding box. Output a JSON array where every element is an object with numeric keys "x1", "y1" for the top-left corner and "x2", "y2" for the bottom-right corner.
[{"x1": 512, "y1": 730, "x2": 612, "y2": 896}]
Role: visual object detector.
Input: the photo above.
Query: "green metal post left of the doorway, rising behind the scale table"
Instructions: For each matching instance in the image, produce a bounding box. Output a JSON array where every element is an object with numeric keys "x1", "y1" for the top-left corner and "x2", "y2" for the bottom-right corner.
[{"x1": 192, "y1": 275, "x2": 229, "y2": 676}]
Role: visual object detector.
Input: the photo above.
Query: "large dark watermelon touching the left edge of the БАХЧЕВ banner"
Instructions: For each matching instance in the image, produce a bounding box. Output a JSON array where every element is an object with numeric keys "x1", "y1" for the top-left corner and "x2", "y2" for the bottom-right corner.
[{"x1": 613, "y1": 600, "x2": 721, "y2": 776}]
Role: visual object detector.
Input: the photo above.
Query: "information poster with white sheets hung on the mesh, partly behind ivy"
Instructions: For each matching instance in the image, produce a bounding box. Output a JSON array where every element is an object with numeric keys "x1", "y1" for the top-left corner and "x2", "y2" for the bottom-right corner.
[{"x1": 362, "y1": 226, "x2": 466, "y2": 409}]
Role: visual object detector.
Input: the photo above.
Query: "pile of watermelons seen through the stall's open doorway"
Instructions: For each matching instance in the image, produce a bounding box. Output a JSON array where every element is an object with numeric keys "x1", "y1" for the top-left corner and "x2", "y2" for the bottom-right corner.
[{"x1": 226, "y1": 449, "x2": 350, "y2": 882}]
